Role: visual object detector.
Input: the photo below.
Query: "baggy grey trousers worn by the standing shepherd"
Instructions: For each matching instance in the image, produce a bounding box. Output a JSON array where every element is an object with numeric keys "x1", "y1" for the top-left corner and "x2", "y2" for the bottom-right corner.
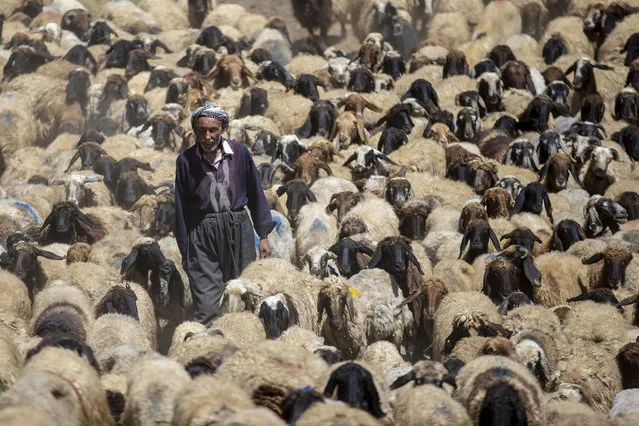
[{"x1": 186, "y1": 210, "x2": 256, "y2": 326}]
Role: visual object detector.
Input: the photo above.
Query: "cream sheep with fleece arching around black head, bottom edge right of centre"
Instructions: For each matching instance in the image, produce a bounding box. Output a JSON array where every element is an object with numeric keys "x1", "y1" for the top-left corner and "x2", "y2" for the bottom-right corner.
[{"x1": 454, "y1": 355, "x2": 545, "y2": 425}]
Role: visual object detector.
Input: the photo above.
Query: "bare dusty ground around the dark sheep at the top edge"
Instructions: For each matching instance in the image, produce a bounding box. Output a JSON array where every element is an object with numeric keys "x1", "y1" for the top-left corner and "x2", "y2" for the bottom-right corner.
[{"x1": 218, "y1": 0, "x2": 359, "y2": 51}]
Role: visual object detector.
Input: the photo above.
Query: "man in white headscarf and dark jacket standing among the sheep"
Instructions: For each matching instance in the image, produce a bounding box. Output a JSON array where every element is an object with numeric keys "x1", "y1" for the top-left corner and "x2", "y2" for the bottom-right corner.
[{"x1": 175, "y1": 102, "x2": 275, "y2": 326}]
